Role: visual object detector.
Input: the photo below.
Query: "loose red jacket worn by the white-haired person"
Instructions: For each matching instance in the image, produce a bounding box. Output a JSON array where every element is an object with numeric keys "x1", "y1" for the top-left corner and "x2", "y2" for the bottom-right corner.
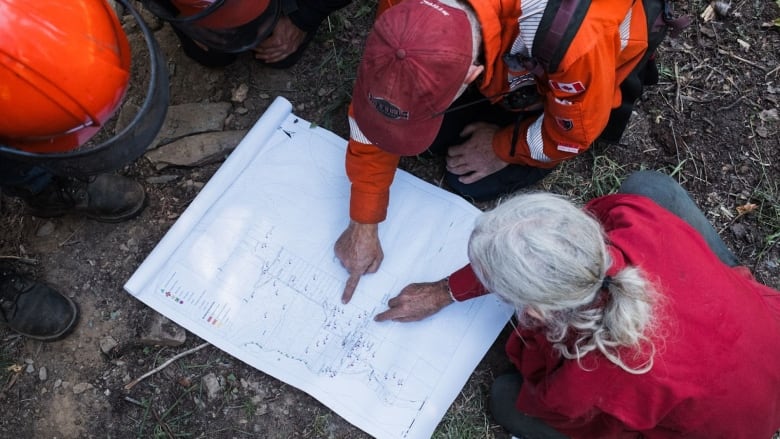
[{"x1": 450, "y1": 195, "x2": 780, "y2": 439}]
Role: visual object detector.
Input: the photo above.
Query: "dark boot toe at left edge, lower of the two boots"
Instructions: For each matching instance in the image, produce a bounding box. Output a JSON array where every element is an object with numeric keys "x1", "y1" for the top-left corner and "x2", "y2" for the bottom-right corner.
[{"x1": 0, "y1": 272, "x2": 79, "y2": 341}]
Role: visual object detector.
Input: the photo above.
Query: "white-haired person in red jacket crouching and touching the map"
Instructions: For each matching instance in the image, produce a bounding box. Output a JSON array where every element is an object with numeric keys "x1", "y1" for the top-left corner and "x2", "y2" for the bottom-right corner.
[{"x1": 375, "y1": 171, "x2": 780, "y2": 438}]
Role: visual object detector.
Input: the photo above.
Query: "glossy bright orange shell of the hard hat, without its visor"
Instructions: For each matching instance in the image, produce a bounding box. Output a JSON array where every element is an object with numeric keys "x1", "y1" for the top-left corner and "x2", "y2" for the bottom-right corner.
[{"x1": 0, "y1": 0, "x2": 130, "y2": 153}]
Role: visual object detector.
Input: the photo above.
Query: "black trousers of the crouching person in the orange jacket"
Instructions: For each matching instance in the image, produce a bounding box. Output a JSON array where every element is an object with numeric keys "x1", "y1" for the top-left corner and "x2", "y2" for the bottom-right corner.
[{"x1": 428, "y1": 87, "x2": 552, "y2": 205}]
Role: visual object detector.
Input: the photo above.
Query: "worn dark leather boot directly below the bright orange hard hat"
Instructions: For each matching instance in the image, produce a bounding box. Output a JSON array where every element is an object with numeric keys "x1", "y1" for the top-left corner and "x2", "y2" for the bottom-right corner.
[{"x1": 21, "y1": 174, "x2": 146, "y2": 223}]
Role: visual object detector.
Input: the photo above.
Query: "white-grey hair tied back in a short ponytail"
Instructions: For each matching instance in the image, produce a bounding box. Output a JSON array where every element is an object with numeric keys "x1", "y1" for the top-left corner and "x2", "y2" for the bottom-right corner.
[{"x1": 469, "y1": 193, "x2": 658, "y2": 374}]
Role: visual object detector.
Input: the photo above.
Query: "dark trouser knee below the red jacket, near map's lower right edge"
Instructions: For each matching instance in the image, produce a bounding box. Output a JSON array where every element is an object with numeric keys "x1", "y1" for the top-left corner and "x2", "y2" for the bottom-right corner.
[{"x1": 490, "y1": 373, "x2": 566, "y2": 439}]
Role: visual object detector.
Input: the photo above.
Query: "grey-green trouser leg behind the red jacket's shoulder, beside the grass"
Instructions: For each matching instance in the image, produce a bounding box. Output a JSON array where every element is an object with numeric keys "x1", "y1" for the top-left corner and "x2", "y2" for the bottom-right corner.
[{"x1": 619, "y1": 171, "x2": 739, "y2": 267}]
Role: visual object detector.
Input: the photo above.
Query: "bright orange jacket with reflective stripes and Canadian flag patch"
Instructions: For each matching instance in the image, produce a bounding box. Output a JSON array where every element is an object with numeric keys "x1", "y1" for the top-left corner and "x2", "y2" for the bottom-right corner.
[{"x1": 346, "y1": 0, "x2": 647, "y2": 224}]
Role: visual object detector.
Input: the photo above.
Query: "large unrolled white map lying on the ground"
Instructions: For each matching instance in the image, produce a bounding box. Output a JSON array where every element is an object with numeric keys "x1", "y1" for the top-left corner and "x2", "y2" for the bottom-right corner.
[{"x1": 125, "y1": 98, "x2": 511, "y2": 439}]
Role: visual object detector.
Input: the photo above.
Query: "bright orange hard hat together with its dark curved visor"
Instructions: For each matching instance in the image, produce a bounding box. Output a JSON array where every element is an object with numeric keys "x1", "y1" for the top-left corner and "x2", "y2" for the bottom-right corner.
[{"x1": 0, "y1": 0, "x2": 169, "y2": 177}]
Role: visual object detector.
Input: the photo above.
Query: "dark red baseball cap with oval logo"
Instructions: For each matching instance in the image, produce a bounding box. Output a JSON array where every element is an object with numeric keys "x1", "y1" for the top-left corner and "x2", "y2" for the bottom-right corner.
[{"x1": 352, "y1": 0, "x2": 473, "y2": 155}]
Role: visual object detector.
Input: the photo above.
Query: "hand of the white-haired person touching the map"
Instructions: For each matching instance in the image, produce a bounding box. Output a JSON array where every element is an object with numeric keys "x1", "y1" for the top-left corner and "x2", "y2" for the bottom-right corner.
[{"x1": 374, "y1": 279, "x2": 452, "y2": 322}]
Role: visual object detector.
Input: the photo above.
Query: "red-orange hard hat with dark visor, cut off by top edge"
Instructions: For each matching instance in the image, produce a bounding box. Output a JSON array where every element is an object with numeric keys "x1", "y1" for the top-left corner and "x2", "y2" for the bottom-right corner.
[{"x1": 142, "y1": 0, "x2": 282, "y2": 53}]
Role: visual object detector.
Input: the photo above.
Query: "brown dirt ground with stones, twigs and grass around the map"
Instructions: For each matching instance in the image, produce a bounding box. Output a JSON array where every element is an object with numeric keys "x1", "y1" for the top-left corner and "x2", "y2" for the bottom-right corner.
[{"x1": 0, "y1": 0, "x2": 780, "y2": 438}]
